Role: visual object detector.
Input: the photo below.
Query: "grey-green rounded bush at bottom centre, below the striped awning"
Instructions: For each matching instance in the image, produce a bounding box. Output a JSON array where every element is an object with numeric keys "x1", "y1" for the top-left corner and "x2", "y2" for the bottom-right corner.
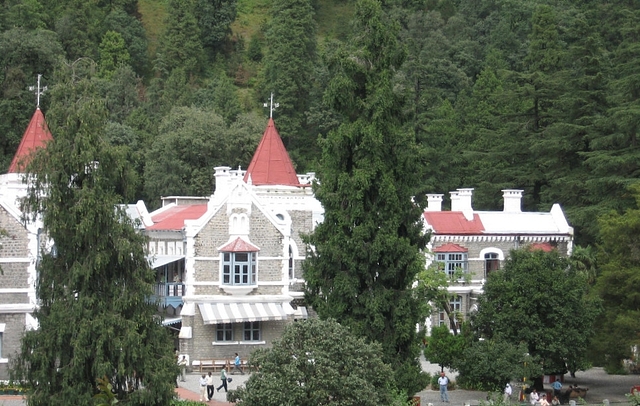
[{"x1": 227, "y1": 319, "x2": 406, "y2": 406}]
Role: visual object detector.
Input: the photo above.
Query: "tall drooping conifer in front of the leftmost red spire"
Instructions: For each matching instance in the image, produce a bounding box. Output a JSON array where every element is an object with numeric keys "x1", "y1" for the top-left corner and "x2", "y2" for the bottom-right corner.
[{"x1": 12, "y1": 61, "x2": 178, "y2": 406}]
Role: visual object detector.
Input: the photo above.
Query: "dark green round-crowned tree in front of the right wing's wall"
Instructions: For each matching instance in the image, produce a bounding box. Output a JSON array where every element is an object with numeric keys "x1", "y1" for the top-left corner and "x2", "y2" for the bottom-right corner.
[{"x1": 472, "y1": 248, "x2": 600, "y2": 374}]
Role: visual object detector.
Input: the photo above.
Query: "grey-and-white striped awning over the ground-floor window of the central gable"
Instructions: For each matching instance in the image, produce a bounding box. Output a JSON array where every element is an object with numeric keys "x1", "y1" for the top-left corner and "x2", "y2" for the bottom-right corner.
[{"x1": 198, "y1": 303, "x2": 287, "y2": 324}]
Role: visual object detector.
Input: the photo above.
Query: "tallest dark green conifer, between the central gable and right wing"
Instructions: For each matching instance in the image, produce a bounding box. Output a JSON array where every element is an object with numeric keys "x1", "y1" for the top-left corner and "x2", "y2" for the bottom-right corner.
[{"x1": 304, "y1": 0, "x2": 427, "y2": 395}]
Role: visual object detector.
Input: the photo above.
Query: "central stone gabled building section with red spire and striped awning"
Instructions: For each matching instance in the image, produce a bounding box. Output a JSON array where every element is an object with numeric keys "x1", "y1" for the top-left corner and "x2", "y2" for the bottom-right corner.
[{"x1": 139, "y1": 119, "x2": 323, "y2": 363}]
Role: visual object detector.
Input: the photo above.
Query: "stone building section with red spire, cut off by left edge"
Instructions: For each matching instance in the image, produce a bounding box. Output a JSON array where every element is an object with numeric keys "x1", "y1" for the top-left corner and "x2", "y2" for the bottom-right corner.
[{"x1": 0, "y1": 109, "x2": 52, "y2": 379}]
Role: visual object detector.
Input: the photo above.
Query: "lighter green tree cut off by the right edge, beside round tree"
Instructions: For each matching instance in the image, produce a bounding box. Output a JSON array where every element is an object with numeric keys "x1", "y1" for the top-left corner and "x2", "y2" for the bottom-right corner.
[{"x1": 593, "y1": 185, "x2": 640, "y2": 373}]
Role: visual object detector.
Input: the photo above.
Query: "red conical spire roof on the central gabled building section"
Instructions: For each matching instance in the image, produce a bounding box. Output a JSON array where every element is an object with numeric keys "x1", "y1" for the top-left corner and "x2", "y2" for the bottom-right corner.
[{"x1": 244, "y1": 118, "x2": 300, "y2": 186}]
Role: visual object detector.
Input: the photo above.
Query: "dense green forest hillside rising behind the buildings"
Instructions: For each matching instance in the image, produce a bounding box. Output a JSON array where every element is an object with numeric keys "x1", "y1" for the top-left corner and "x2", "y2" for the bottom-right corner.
[{"x1": 0, "y1": 0, "x2": 640, "y2": 245}]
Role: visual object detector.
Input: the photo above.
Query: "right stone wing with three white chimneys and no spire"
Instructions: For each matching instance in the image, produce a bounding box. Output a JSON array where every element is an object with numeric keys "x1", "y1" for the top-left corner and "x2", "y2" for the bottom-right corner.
[{"x1": 423, "y1": 189, "x2": 573, "y2": 329}]
